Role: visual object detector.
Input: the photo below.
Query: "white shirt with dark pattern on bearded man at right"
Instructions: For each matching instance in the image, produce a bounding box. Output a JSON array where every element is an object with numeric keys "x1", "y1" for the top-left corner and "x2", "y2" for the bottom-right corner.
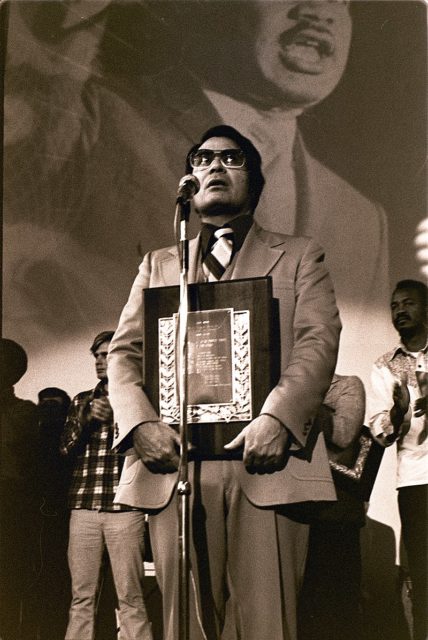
[{"x1": 370, "y1": 344, "x2": 428, "y2": 488}]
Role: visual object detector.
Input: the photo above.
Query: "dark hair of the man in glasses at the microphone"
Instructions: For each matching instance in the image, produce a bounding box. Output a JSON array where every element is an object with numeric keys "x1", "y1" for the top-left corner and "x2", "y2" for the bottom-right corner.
[{"x1": 186, "y1": 124, "x2": 265, "y2": 209}]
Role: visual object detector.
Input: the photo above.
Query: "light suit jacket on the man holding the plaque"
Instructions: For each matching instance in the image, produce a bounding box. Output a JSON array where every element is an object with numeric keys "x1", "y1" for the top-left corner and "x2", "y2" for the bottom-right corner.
[{"x1": 108, "y1": 224, "x2": 340, "y2": 509}]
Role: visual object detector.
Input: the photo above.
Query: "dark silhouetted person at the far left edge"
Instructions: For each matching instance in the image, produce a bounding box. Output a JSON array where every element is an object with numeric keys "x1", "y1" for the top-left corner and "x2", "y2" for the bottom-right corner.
[{"x1": 0, "y1": 338, "x2": 40, "y2": 640}]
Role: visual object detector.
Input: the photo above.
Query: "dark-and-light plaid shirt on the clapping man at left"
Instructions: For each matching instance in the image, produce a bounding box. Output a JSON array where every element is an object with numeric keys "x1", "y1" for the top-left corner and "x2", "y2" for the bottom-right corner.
[{"x1": 60, "y1": 382, "x2": 133, "y2": 511}]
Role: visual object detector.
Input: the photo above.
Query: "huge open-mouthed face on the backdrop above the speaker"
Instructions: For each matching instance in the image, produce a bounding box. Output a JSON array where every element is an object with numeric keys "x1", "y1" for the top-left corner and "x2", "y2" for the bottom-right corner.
[{"x1": 251, "y1": 0, "x2": 352, "y2": 108}]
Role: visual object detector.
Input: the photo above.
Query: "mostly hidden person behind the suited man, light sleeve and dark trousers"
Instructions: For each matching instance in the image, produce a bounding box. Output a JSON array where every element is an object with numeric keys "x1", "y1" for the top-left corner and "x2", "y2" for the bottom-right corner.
[{"x1": 299, "y1": 374, "x2": 366, "y2": 640}]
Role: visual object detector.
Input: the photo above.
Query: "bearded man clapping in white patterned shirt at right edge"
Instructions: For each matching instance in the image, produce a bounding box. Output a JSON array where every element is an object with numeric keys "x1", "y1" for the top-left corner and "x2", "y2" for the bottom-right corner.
[{"x1": 370, "y1": 280, "x2": 428, "y2": 640}]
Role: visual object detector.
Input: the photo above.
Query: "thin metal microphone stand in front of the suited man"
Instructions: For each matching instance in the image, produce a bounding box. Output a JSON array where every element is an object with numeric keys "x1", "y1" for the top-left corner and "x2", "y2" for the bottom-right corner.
[{"x1": 175, "y1": 196, "x2": 191, "y2": 640}]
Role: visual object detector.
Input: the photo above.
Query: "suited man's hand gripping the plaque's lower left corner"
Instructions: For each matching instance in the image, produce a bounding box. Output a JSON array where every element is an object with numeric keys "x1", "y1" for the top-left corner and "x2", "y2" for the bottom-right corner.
[{"x1": 132, "y1": 420, "x2": 180, "y2": 473}]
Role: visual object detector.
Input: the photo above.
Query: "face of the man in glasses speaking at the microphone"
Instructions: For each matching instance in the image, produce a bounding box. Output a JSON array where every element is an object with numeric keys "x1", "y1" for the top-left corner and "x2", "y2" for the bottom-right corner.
[{"x1": 193, "y1": 137, "x2": 251, "y2": 221}]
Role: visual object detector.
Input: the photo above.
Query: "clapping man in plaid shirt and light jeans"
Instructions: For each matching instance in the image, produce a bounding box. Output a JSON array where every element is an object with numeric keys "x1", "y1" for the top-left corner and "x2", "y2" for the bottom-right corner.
[{"x1": 61, "y1": 331, "x2": 152, "y2": 640}]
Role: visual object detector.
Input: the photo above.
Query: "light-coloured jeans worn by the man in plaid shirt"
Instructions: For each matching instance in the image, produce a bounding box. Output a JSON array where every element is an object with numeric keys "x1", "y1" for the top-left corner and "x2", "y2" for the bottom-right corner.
[{"x1": 65, "y1": 509, "x2": 153, "y2": 640}]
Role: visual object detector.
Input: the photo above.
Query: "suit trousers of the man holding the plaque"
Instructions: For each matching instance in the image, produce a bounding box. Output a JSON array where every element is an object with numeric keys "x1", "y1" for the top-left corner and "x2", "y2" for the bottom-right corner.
[{"x1": 150, "y1": 461, "x2": 309, "y2": 640}]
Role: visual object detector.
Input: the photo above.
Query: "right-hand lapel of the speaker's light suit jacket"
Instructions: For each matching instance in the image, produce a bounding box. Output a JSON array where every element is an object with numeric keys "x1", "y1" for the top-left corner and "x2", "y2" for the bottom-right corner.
[{"x1": 226, "y1": 223, "x2": 284, "y2": 280}]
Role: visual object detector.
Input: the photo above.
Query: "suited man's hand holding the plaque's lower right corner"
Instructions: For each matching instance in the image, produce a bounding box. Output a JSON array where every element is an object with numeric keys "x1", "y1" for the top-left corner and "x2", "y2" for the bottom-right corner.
[{"x1": 224, "y1": 415, "x2": 290, "y2": 473}]
